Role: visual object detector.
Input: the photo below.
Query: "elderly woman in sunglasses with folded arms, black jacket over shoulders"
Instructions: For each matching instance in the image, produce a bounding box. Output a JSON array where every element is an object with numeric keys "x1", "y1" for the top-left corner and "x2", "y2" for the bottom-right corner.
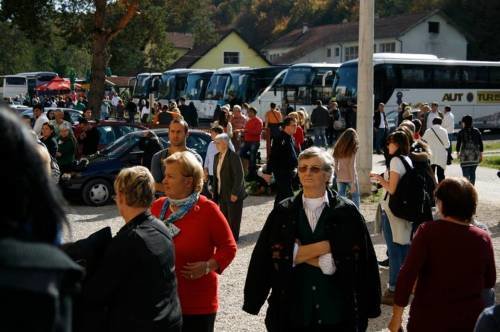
[{"x1": 243, "y1": 147, "x2": 381, "y2": 331}]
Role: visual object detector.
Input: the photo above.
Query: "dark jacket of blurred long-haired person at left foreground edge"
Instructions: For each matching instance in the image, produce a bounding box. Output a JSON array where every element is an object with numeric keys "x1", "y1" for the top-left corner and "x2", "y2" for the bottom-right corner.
[{"x1": 0, "y1": 238, "x2": 83, "y2": 332}]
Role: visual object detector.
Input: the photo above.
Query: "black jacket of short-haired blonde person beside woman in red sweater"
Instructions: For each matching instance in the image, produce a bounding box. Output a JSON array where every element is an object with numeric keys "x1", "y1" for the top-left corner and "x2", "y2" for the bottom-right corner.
[{"x1": 81, "y1": 212, "x2": 182, "y2": 332}]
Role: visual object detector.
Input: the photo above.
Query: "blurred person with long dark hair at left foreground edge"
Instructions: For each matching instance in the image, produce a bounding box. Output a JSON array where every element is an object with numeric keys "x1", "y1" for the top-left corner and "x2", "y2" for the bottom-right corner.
[{"x1": 0, "y1": 110, "x2": 82, "y2": 331}]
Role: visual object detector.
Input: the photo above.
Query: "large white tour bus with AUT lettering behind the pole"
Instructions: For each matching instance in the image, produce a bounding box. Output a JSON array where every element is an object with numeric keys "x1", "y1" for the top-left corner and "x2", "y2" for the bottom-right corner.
[{"x1": 334, "y1": 53, "x2": 500, "y2": 130}]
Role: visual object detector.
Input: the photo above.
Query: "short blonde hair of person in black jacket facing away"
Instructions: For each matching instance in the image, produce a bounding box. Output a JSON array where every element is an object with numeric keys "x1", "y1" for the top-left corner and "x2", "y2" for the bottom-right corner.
[{"x1": 115, "y1": 166, "x2": 155, "y2": 208}]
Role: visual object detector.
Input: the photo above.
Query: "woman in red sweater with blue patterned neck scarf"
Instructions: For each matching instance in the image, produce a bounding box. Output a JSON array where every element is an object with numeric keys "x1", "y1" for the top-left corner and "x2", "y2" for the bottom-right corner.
[{"x1": 151, "y1": 151, "x2": 236, "y2": 332}]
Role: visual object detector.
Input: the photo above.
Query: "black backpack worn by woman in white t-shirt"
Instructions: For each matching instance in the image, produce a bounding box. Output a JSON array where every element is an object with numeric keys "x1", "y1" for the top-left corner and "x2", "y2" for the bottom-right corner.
[{"x1": 389, "y1": 156, "x2": 435, "y2": 224}]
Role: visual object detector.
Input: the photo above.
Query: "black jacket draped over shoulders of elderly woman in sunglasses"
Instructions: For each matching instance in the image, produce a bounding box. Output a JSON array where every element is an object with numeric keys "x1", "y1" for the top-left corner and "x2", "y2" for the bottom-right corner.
[{"x1": 243, "y1": 191, "x2": 381, "y2": 331}]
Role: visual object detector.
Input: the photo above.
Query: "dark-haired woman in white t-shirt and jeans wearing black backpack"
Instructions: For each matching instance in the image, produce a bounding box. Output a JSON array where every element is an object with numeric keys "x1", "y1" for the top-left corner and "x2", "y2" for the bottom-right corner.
[{"x1": 370, "y1": 131, "x2": 413, "y2": 305}]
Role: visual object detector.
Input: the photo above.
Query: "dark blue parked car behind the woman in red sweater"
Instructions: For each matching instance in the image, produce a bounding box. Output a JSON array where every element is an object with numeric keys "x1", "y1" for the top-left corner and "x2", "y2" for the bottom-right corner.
[{"x1": 59, "y1": 128, "x2": 211, "y2": 206}]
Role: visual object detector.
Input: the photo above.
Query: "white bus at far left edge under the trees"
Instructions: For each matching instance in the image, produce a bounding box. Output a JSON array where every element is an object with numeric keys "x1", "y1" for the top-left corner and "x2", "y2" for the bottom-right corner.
[{"x1": 2, "y1": 71, "x2": 57, "y2": 98}]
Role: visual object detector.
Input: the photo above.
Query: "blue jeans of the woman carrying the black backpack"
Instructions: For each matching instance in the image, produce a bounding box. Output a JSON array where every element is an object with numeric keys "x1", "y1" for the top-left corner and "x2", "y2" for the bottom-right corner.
[{"x1": 382, "y1": 212, "x2": 410, "y2": 291}]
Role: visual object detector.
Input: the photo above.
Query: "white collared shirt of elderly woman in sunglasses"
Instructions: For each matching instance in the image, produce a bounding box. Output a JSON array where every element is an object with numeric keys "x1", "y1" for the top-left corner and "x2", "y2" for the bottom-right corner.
[{"x1": 293, "y1": 190, "x2": 336, "y2": 275}]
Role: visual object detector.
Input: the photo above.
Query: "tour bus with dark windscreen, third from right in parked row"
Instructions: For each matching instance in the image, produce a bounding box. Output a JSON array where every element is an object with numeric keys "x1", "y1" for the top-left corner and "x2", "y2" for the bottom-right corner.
[{"x1": 200, "y1": 66, "x2": 288, "y2": 119}]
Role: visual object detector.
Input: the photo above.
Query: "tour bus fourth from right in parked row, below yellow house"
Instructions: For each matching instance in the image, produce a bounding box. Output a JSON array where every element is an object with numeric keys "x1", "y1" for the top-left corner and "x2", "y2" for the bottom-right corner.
[{"x1": 184, "y1": 69, "x2": 215, "y2": 119}]
